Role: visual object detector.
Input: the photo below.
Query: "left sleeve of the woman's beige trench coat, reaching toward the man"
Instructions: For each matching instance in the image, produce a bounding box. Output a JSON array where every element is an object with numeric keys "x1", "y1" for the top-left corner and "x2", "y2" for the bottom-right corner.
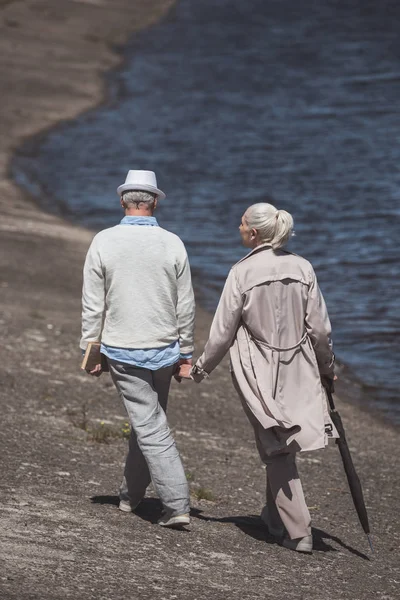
[{"x1": 192, "y1": 269, "x2": 244, "y2": 381}]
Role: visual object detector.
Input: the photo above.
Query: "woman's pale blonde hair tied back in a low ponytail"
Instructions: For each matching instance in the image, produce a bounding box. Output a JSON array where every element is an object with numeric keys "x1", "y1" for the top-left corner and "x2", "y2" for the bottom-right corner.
[{"x1": 244, "y1": 202, "x2": 293, "y2": 250}]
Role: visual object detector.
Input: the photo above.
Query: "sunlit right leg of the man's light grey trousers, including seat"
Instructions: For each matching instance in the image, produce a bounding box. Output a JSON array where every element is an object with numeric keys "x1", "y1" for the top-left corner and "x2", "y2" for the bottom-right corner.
[{"x1": 109, "y1": 361, "x2": 189, "y2": 516}]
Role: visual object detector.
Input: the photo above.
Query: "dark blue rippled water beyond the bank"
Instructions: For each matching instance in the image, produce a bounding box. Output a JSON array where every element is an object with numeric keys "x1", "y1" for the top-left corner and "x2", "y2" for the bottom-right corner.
[{"x1": 13, "y1": 0, "x2": 400, "y2": 422}]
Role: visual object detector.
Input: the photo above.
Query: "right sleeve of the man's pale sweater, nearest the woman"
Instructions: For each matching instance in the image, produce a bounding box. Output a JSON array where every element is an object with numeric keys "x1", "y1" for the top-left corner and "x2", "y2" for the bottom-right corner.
[{"x1": 176, "y1": 244, "x2": 195, "y2": 354}]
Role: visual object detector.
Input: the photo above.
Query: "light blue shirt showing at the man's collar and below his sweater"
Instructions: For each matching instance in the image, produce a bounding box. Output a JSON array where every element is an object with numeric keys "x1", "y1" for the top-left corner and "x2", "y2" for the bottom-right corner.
[{"x1": 101, "y1": 216, "x2": 192, "y2": 371}]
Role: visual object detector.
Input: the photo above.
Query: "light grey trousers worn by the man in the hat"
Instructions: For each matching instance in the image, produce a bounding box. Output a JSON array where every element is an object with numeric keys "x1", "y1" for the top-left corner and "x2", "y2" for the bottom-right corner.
[{"x1": 108, "y1": 359, "x2": 190, "y2": 516}]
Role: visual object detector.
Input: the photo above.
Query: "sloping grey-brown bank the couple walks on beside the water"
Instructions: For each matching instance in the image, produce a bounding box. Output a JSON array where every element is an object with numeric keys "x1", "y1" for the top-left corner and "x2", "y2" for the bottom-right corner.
[{"x1": 0, "y1": 0, "x2": 400, "y2": 600}]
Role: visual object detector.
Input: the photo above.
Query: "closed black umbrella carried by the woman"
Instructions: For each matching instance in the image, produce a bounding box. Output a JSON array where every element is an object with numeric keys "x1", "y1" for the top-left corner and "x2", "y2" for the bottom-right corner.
[{"x1": 326, "y1": 385, "x2": 374, "y2": 552}]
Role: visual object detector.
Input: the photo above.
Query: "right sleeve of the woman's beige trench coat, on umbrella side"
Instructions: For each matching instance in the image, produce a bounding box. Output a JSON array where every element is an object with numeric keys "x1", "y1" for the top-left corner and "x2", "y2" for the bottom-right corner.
[{"x1": 305, "y1": 270, "x2": 335, "y2": 376}]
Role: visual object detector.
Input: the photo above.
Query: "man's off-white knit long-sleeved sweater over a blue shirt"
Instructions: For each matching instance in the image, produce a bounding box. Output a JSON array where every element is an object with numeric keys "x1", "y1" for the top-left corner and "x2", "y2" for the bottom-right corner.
[{"x1": 80, "y1": 225, "x2": 195, "y2": 354}]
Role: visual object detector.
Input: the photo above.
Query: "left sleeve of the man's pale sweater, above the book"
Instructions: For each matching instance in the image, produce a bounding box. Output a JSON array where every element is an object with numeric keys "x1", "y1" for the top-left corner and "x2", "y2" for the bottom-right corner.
[{"x1": 80, "y1": 238, "x2": 105, "y2": 350}]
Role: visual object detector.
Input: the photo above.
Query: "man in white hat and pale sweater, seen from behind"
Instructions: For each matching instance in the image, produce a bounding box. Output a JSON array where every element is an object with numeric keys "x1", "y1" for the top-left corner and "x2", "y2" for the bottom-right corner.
[{"x1": 81, "y1": 171, "x2": 195, "y2": 527}]
